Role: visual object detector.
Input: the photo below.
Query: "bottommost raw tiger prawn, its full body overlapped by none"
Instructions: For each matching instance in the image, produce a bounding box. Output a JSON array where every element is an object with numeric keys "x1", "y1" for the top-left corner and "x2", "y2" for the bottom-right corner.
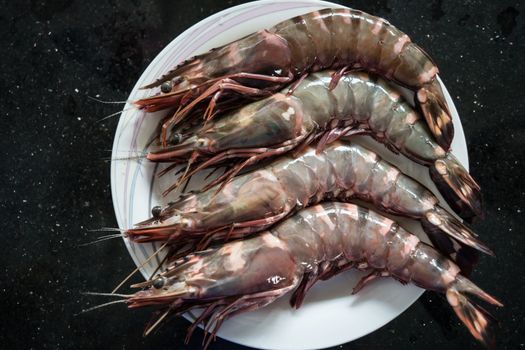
[{"x1": 121, "y1": 202, "x2": 502, "y2": 346}]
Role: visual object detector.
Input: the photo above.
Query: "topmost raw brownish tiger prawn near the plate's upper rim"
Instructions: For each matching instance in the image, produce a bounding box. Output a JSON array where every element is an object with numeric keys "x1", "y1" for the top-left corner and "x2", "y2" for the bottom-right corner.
[{"x1": 135, "y1": 8, "x2": 454, "y2": 151}]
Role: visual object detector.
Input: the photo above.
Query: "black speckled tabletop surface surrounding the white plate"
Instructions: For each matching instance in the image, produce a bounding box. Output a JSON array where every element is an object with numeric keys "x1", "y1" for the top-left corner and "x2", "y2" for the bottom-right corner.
[{"x1": 0, "y1": 0, "x2": 525, "y2": 350}]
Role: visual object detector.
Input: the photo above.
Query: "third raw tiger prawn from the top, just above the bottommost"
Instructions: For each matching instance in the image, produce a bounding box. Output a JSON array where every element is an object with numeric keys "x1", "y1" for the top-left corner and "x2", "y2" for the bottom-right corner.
[{"x1": 125, "y1": 141, "x2": 492, "y2": 260}]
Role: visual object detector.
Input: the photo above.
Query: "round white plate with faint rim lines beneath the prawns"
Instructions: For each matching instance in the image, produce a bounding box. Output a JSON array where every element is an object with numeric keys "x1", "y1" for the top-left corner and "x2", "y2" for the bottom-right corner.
[{"x1": 111, "y1": 0, "x2": 468, "y2": 350}]
